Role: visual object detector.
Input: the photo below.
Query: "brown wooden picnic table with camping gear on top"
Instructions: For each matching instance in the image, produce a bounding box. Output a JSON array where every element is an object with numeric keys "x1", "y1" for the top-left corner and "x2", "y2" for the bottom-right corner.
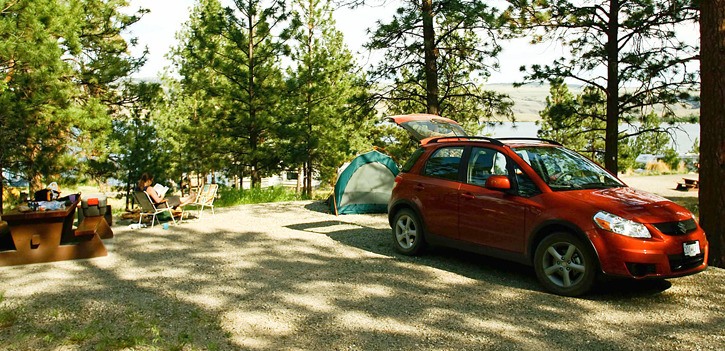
[{"x1": 0, "y1": 197, "x2": 113, "y2": 266}]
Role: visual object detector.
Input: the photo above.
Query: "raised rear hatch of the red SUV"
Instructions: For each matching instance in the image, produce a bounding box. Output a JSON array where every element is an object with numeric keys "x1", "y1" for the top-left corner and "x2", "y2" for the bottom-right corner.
[{"x1": 385, "y1": 114, "x2": 468, "y2": 143}]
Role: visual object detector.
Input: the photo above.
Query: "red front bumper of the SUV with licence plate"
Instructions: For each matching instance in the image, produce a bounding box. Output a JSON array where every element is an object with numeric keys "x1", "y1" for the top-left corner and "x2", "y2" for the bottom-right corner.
[{"x1": 590, "y1": 227, "x2": 709, "y2": 279}]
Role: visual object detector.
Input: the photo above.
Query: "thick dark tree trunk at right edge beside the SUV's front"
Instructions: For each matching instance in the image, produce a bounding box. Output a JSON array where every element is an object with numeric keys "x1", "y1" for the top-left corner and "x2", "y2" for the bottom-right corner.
[{"x1": 699, "y1": 0, "x2": 725, "y2": 268}]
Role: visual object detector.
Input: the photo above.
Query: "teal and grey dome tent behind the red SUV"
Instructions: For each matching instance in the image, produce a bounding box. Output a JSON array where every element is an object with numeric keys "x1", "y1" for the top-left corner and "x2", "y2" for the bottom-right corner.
[{"x1": 330, "y1": 151, "x2": 400, "y2": 214}]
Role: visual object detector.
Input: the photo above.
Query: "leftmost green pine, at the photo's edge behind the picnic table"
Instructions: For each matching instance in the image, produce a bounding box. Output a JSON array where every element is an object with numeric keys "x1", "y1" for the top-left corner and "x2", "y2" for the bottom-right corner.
[{"x1": 0, "y1": 0, "x2": 75, "y2": 204}]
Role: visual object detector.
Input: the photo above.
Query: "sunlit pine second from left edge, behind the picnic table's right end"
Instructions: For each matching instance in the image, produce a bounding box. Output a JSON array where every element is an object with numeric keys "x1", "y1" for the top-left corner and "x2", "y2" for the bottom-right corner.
[{"x1": 65, "y1": 0, "x2": 147, "y2": 187}]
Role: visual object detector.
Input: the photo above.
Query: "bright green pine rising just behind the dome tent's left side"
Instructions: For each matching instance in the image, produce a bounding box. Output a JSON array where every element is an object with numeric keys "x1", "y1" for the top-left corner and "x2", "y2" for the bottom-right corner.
[{"x1": 285, "y1": 0, "x2": 372, "y2": 195}]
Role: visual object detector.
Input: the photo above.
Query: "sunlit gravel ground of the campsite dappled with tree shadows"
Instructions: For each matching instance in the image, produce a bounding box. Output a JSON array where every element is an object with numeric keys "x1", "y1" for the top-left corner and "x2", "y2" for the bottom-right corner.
[{"x1": 0, "y1": 179, "x2": 725, "y2": 350}]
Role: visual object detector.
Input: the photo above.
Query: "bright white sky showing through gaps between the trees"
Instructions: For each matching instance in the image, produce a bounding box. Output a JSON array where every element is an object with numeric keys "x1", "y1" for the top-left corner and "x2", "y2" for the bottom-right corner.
[{"x1": 127, "y1": 0, "x2": 697, "y2": 83}]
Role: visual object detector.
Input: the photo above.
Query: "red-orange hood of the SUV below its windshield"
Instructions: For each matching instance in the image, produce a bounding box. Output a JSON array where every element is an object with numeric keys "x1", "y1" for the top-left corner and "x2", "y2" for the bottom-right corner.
[{"x1": 560, "y1": 187, "x2": 692, "y2": 223}]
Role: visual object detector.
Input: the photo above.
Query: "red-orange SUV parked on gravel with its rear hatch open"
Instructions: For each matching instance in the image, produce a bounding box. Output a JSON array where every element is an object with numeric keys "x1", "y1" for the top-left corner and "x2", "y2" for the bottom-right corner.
[{"x1": 388, "y1": 115, "x2": 708, "y2": 296}]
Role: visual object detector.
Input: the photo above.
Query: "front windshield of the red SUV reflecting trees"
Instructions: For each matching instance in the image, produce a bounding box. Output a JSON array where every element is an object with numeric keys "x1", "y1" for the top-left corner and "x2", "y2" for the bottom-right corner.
[{"x1": 514, "y1": 146, "x2": 625, "y2": 191}]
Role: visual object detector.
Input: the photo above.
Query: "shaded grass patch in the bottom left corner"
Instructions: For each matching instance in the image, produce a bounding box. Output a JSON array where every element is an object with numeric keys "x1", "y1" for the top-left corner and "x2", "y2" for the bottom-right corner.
[{"x1": 0, "y1": 296, "x2": 233, "y2": 351}]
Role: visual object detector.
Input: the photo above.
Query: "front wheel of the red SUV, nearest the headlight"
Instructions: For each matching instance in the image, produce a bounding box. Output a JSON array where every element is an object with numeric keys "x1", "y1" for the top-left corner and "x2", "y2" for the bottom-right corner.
[{"x1": 534, "y1": 232, "x2": 599, "y2": 296}]
